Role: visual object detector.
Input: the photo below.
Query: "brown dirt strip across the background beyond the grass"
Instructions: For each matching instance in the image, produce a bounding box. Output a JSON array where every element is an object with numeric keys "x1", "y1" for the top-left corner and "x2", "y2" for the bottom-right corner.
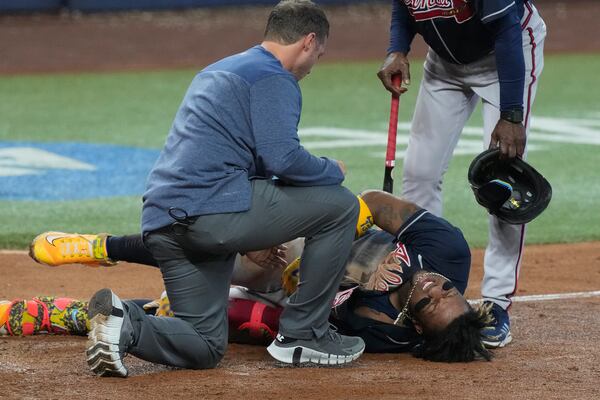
[{"x1": 0, "y1": 0, "x2": 600, "y2": 74}]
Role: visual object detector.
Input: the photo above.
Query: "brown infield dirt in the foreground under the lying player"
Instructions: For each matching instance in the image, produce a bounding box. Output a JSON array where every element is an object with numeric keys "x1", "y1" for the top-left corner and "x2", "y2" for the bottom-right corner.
[{"x1": 0, "y1": 243, "x2": 600, "y2": 400}]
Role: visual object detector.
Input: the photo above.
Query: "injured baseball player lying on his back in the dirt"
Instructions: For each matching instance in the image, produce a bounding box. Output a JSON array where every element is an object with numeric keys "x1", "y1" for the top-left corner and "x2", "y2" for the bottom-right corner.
[{"x1": 5, "y1": 191, "x2": 491, "y2": 362}]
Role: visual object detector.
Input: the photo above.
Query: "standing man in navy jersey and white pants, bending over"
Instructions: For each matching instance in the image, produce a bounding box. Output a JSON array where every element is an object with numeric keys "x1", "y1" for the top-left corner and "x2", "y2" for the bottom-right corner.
[{"x1": 378, "y1": 0, "x2": 546, "y2": 347}]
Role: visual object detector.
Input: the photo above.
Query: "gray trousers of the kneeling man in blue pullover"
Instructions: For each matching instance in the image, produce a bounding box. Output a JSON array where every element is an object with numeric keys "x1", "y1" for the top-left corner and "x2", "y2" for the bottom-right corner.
[{"x1": 125, "y1": 180, "x2": 359, "y2": 369}]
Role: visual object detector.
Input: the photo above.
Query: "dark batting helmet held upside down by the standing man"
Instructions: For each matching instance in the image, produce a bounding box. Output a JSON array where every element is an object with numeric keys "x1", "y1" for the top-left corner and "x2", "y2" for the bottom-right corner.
[{"x1": 469, "y1": 148, "x2": 552, "y2": 224}]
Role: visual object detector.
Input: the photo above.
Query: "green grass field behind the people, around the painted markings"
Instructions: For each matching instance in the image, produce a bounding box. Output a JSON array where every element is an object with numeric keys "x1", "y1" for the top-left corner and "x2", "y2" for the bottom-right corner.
[{"x1": 0, "y1": 55, "x2": 600, "y2": 248}]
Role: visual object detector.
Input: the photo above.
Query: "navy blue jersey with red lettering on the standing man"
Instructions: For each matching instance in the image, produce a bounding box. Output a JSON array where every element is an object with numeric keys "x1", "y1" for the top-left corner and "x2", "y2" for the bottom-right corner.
[{"x1": 389, "y1": 0, "x2": 526, "y2": 64}]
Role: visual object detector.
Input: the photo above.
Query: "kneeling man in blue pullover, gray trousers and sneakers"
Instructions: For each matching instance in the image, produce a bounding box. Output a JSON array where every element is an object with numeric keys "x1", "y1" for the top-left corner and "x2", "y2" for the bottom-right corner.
[{"x1": 87, "y1": 0, "x2": 365, "y2": 376}]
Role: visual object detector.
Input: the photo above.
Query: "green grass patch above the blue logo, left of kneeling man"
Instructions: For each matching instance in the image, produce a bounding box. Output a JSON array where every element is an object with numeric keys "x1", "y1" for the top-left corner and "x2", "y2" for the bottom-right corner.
[{"x1": 0, "y1": 71, "x2": 194, "y2": 147}]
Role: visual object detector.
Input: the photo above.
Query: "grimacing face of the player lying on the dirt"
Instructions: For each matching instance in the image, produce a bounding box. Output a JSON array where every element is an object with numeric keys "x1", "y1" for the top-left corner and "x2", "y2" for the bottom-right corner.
[{"x1": 409, "y1": 276, "x2": 469, "y2": 332}]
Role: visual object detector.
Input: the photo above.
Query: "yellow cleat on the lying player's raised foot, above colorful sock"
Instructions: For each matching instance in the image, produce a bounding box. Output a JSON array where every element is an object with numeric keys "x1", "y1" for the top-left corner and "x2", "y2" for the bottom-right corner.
[{"x1": 29, "y1": 232, "x2": 116, "y2": 267}]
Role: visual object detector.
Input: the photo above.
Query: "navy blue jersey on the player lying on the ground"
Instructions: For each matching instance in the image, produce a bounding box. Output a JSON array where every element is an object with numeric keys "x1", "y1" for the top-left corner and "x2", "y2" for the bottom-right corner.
[{"x1": 331, "y1": 210, "x2": 471, "y2": 352}]
